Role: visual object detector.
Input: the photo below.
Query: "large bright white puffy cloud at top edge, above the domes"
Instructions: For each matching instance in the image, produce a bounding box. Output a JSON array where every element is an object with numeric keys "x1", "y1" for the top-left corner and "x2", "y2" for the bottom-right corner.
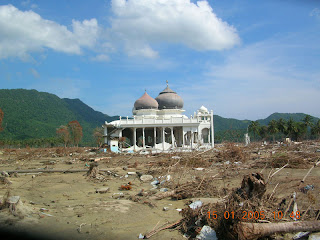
[{"x1": 111, "y1": 0, "x2": 240, "y2": 58}]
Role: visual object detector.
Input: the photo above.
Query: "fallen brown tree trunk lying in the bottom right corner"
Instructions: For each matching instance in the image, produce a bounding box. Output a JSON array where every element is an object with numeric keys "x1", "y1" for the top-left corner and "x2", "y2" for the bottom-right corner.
[{"x1": 236, "y1": 221, "x2": 320, "y2": 240}]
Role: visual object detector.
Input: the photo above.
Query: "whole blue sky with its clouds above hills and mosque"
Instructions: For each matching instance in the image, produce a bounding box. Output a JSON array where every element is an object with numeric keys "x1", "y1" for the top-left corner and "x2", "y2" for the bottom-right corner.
[{"x1": 0, "y1": 0, "x2": 320, "y2": 120}]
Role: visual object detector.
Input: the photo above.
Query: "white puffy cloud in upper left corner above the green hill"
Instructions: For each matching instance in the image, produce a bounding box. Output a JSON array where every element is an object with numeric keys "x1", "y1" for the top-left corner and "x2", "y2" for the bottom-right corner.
[{"x1": 0, "y1": 5, "x2": 99, "y2": 59}]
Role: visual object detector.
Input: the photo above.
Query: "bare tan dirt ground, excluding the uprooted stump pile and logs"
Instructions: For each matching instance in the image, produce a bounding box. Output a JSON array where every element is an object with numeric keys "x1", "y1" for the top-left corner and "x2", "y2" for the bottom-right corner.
[{"x1": 0, "y1": 141, "x2": 320, "y2": 240}]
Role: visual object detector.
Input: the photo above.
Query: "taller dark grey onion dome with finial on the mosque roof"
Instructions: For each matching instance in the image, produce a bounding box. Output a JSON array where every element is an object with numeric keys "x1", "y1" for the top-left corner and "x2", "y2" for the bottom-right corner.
[{"x1": 156, "y1": 84, "x2": 183, "y2": 109}]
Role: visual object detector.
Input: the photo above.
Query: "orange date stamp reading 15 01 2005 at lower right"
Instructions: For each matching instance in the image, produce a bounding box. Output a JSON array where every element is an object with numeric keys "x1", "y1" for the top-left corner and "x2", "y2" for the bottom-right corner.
[{"x1": 207, "y1": 211, "x2": 301, "y2": 220}]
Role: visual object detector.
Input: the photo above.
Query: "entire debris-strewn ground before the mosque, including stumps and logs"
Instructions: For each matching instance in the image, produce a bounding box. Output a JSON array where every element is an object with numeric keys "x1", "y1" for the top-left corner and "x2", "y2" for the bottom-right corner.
[{"x1": 0, "y1": 141, "x2": 320, "y2": 239}]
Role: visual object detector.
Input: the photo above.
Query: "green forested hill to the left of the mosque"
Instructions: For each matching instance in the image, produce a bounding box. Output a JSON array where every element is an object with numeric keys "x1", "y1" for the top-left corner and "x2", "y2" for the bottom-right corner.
[{"x1": 0, "y1": 89, "x2": 117, "y2": 143}]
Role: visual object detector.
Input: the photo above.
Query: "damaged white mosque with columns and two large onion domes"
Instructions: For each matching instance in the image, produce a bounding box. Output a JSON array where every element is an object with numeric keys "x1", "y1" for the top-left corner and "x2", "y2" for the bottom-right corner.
[{"x1": 103, "y1": 82, "x2": 214, "y2": 152}]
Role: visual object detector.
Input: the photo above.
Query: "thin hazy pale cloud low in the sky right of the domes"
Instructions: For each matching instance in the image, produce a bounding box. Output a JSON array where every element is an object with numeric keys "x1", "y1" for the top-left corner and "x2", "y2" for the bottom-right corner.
[{"x1": 181, "y1": 36, "x2": 320, "y2": 120}]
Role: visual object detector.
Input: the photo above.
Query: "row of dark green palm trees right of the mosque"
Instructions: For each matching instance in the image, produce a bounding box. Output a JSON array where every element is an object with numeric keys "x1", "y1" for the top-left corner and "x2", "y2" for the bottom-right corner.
[{"x1": 248, "y1": 115, "x2": 320, "y2": 141}]
